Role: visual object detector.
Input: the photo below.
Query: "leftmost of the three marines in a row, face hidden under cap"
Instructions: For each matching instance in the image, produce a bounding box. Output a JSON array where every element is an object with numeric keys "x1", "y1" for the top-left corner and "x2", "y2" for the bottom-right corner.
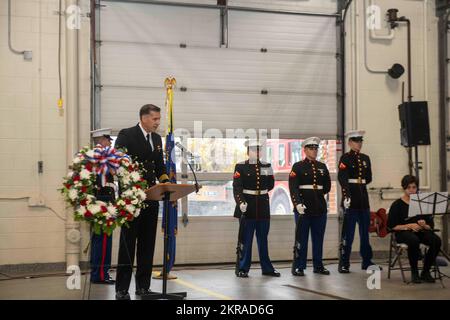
[{"x1": 233, "y1": 140, "x2": 280, "y2": 278}]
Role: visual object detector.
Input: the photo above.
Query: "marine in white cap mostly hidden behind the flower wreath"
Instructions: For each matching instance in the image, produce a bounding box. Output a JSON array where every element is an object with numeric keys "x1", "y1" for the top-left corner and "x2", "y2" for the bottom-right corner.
[{"x1": 91, "y1": 129, "x2": 115, "y2": 284}]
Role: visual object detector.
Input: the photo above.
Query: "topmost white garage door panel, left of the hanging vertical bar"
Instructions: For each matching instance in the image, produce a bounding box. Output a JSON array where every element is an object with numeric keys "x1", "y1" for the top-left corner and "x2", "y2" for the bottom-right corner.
[{"x1": 100, "y1": 1, "x2": 220, "y2": 46}]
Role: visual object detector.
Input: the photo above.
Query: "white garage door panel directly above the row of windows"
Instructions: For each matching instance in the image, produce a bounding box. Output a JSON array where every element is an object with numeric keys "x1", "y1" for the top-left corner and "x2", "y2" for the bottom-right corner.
[{"x1": 102, "y1": 87, "x2": 337, "y2": 137}]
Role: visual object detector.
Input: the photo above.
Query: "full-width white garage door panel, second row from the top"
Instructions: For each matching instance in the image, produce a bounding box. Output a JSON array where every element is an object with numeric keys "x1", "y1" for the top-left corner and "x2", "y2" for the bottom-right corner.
[{"x1": 101, "y1": 43, "x2": 336, "y2": 91}]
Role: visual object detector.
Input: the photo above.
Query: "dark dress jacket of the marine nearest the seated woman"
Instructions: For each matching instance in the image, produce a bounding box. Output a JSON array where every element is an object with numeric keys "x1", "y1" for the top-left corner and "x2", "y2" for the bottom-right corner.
[{"x1": 338, "y1": 151, "x2": 372, "y2": 210}]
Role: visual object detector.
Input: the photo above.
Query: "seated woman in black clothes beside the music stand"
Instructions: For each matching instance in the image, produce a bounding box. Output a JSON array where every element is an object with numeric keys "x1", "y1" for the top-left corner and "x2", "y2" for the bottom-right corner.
[{"x1": 388, "y1": 175, "x2": 441, "y2": 283}]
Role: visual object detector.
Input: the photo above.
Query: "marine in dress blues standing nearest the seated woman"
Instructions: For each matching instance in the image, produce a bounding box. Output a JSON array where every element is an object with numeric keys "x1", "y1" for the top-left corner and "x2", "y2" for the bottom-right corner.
[{"x1": 338, "y1": 130, "x2": 374, "y2": 273}]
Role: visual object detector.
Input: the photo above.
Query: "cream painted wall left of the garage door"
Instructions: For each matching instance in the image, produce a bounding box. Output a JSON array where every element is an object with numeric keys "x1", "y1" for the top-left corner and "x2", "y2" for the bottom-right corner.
[{"x1": 0, "y1": 0, "x2": 90, "y2": 265}]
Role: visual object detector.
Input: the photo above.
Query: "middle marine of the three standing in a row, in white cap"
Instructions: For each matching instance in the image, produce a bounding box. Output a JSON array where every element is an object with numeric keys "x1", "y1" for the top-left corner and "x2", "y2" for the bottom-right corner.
[{"x1": 289, "y1": 137, "x2": 331, "y2": 276}]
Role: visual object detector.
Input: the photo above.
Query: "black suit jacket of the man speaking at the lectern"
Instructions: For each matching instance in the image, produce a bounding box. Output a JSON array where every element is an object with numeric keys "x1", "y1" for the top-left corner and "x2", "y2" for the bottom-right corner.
[{"x1": 115, "y1": 124, "x2": 169, "y2": 192}]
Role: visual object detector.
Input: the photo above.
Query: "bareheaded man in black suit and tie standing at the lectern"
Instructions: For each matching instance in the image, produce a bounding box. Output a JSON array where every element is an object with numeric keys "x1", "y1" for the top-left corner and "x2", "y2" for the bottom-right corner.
[{"x1": 115, "y1": 104, "x2": 169, "y2": 300}]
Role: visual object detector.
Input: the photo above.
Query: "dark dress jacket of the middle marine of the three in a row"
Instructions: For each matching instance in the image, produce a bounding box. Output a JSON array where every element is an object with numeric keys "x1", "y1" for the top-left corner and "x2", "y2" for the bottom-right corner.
[{"x1": 289, "y1": 159, "x2": 331, "y2": 215}]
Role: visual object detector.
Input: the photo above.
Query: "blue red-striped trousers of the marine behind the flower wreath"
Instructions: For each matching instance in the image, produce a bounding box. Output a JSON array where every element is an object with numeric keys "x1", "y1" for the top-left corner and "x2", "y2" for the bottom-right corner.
[{"x1": 91, "y1": 234, "x2": 112, "y2": 282}]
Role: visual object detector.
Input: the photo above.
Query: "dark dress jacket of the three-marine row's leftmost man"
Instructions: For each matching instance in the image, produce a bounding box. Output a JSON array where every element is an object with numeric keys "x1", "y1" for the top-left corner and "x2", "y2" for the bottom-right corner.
[{"x1": 233, "y1": 160, "x2": 275, "y2": 220}]
